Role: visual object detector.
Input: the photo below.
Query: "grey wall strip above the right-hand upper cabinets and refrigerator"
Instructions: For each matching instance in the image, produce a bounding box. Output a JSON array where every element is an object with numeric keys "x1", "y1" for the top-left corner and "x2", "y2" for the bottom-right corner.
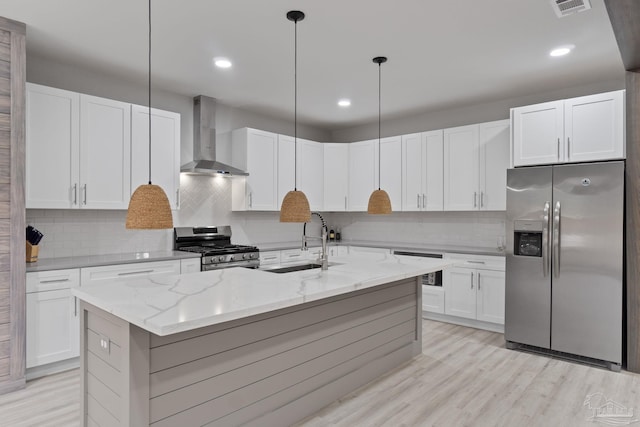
[{"x1": 330, "y1": 74, "x2": 625, "y2": 142}]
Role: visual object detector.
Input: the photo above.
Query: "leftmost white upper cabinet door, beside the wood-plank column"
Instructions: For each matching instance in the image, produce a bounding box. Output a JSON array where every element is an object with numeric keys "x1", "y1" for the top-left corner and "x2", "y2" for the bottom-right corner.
[{"x1": 25, "y1": 83, "x2": 80, "y2": 209}]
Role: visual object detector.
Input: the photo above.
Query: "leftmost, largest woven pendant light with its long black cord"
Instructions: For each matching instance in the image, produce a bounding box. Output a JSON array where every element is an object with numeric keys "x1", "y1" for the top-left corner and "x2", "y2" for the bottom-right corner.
[{"x1": 125, "y1": 0, "x2": 173, "y2": 230}]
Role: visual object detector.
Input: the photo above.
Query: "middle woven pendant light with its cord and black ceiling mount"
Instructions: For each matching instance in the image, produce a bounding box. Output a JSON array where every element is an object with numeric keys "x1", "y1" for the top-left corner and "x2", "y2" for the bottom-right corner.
[{"x1": 280, "y1": 10, "x2": 311, "y2": 222}]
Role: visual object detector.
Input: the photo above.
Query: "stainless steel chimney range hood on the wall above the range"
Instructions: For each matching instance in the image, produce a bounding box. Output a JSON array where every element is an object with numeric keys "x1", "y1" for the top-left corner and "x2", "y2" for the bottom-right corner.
[{"x1": 180, "y1": 95, "x2": 249, "y2": 176}]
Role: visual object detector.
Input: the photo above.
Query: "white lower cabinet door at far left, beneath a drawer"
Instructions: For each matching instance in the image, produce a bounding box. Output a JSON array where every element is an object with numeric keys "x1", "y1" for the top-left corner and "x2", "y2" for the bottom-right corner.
[{"x1": 26, "y1": 289, "x2": 80, "y2": 368}]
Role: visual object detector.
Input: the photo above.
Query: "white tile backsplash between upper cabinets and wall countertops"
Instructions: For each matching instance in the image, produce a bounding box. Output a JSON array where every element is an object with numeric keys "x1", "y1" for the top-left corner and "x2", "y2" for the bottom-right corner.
[{"x1": 27, "y1": 174, "x2": 505, "y2": 258}]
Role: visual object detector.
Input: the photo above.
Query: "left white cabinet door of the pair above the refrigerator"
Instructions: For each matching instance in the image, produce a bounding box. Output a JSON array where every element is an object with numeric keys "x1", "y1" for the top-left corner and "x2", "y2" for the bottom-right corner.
[{"x1": 511, "y1": 101, "x2": 564, "y2": 166}]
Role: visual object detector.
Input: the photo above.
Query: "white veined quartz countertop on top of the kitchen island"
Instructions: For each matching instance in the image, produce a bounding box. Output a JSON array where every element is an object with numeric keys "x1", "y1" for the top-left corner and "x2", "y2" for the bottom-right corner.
[{"x1": 71, "y1": 253, "x2": 456, "y2": 335}]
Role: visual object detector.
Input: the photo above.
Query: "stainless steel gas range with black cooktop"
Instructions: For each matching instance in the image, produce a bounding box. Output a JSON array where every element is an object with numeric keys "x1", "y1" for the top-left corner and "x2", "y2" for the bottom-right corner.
[{"x1": 173, "y1": 225, "x2": 260, "y2": 271}]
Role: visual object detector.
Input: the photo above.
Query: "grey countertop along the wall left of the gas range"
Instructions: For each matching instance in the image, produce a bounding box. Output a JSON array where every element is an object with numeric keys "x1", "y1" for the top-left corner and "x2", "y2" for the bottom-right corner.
[{"x1": 27, "y1": 251, "x2": 200, "y2": 273}]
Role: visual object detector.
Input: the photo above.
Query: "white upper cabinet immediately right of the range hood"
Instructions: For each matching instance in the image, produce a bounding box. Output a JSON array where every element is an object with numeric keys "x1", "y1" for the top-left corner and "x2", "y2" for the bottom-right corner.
[{"x1": 232, "y1": 128, "x2": 278, "y2": 211}]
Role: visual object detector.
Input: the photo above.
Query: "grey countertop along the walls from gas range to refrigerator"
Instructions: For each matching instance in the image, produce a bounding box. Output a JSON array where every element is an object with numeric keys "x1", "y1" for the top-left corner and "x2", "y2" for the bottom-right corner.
[{"x1": 257, "y1": 240, "x2": 504, "y2": 256}]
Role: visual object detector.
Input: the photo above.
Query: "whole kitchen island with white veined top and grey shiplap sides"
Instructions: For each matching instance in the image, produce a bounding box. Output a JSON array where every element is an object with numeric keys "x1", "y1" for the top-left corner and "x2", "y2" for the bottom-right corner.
[{"x1": 73, "y1": 254, "x2": 452, "y2": 427}]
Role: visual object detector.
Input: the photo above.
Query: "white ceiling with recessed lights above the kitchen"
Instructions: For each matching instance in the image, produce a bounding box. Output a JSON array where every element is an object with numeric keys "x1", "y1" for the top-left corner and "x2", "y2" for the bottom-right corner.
[{"x1": 0, "y1": 0, "x2": 623, "y2": 129}]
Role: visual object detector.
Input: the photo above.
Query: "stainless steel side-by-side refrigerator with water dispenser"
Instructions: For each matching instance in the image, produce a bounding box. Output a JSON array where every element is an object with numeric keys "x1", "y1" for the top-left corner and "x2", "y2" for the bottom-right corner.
[{"x1": 505, "y1": 162, "x2": 624, "y2": 370}]
